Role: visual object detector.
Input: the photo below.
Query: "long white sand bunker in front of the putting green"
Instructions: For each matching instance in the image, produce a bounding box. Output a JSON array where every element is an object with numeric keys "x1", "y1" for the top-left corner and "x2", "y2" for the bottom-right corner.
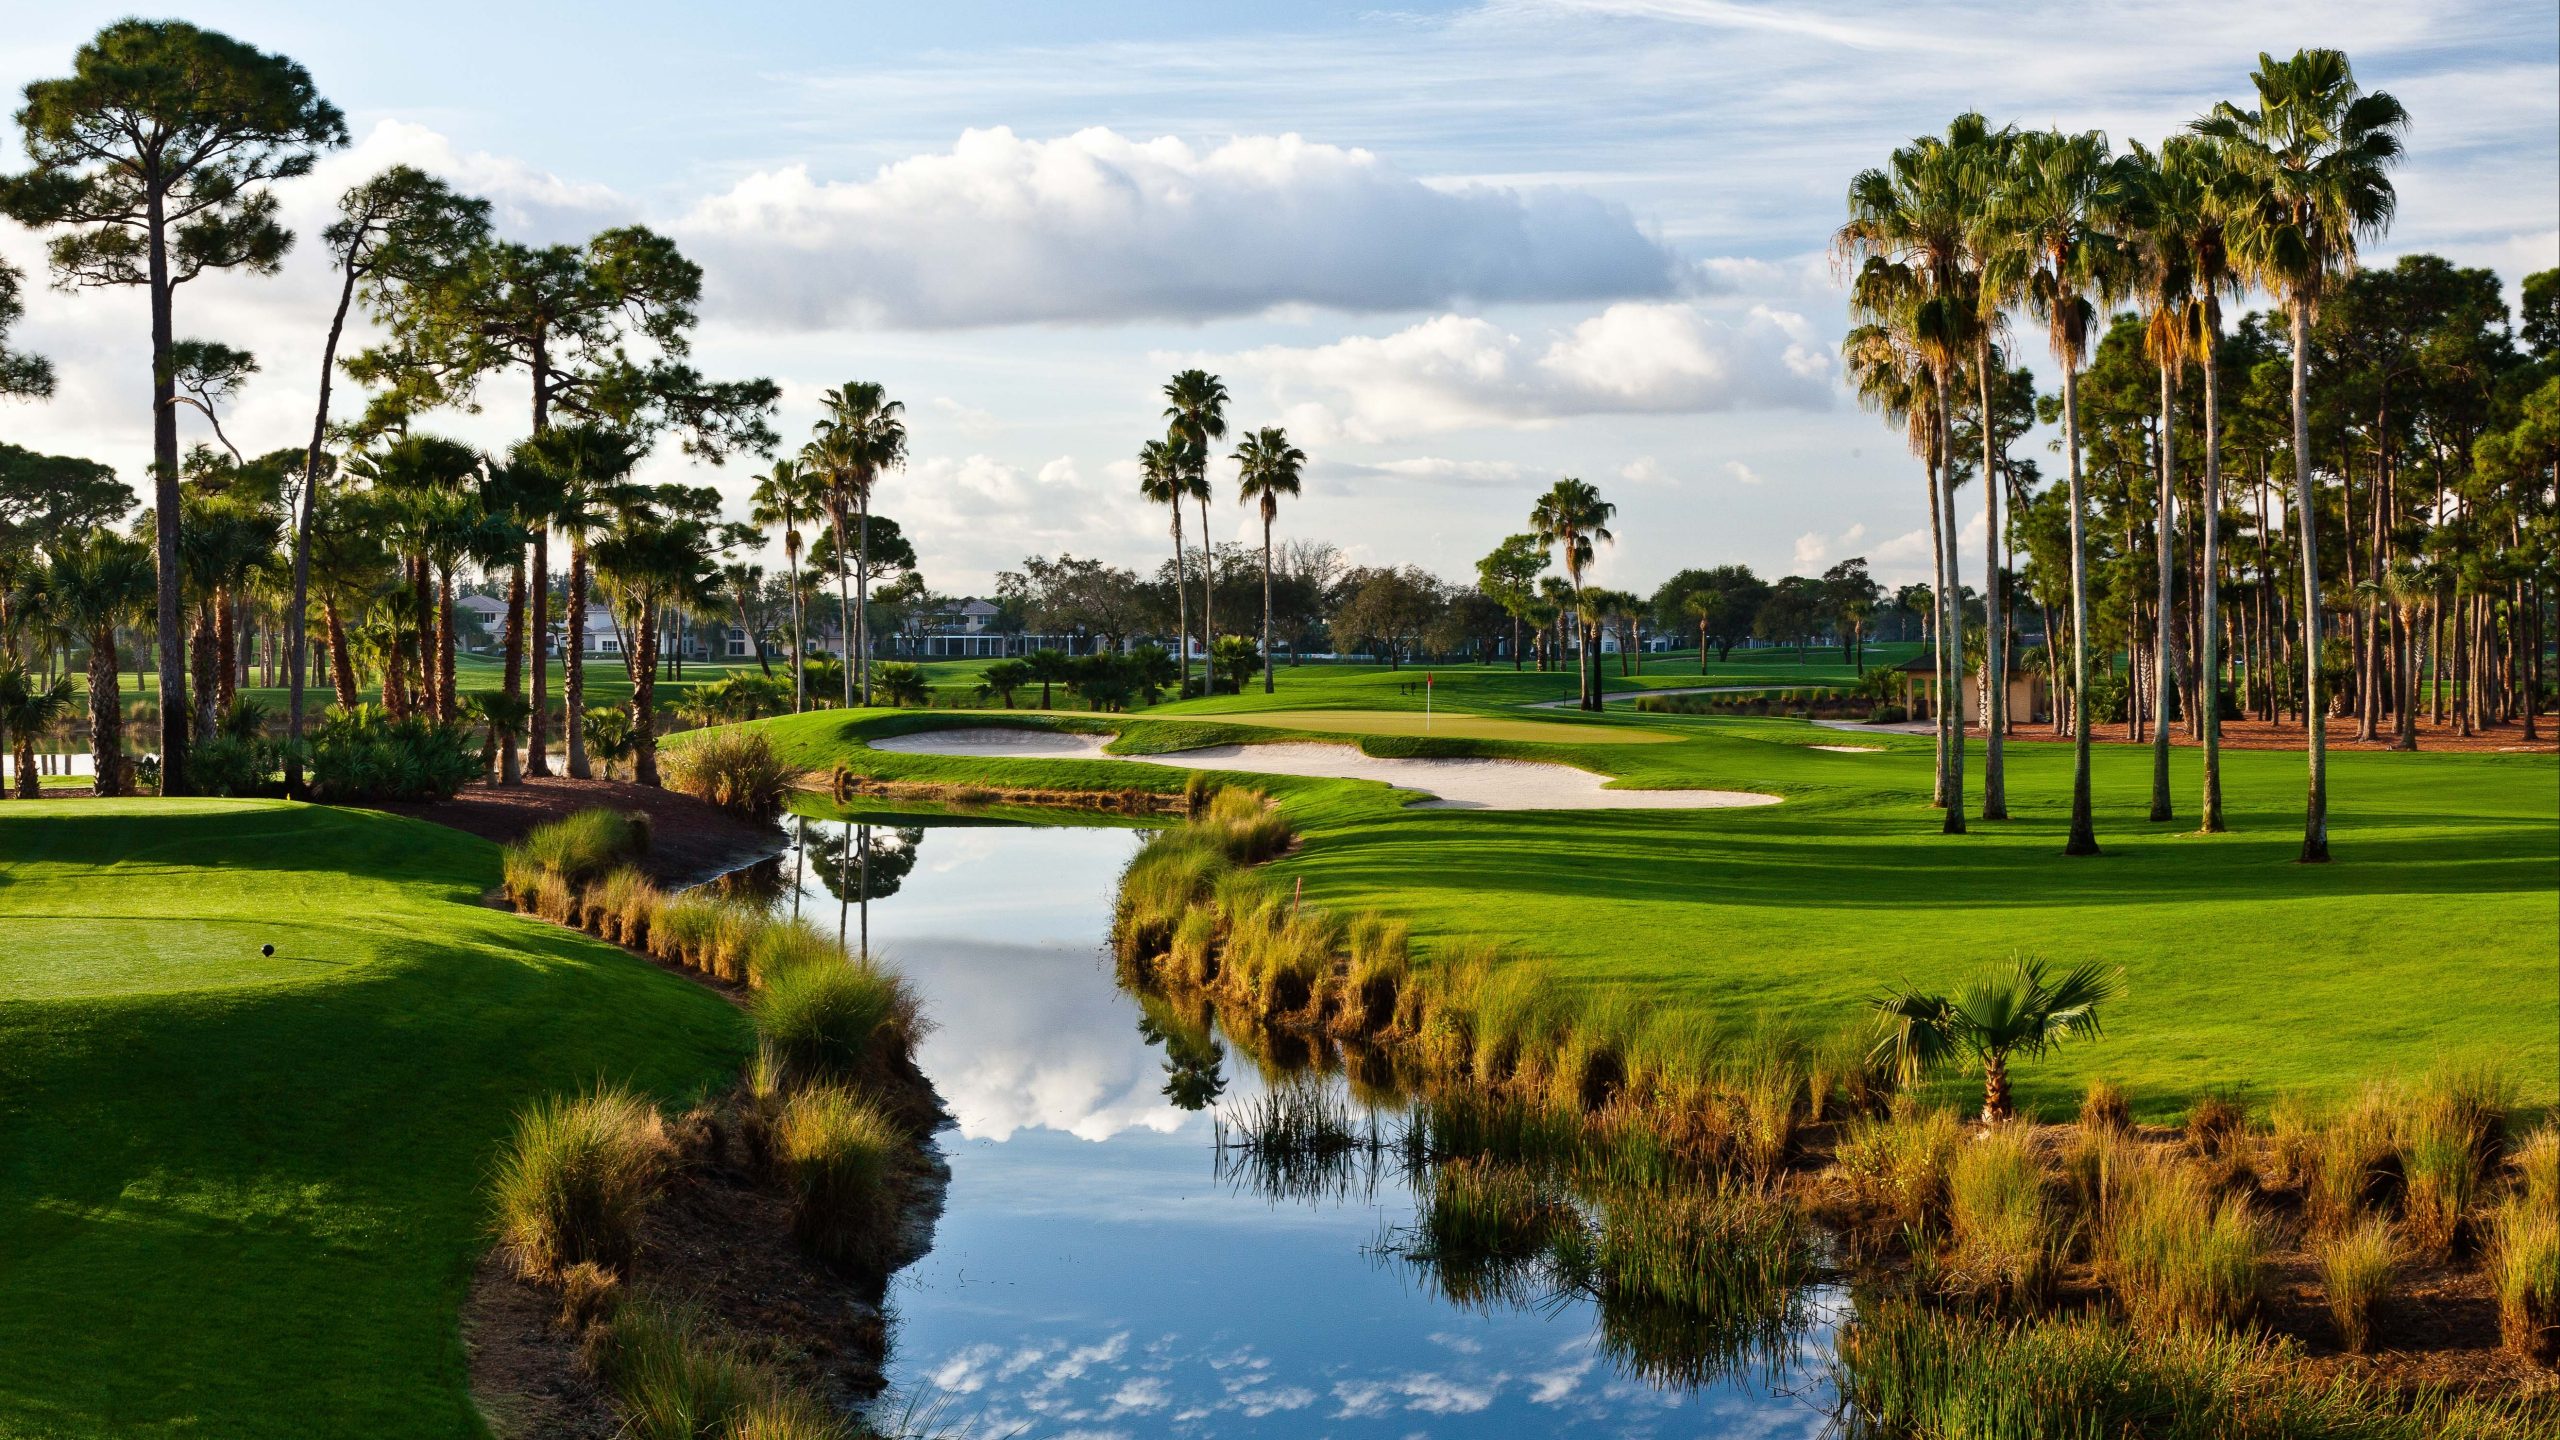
[{"x1": 873, "y1": 728, "x2": 1779, "y2": 810}]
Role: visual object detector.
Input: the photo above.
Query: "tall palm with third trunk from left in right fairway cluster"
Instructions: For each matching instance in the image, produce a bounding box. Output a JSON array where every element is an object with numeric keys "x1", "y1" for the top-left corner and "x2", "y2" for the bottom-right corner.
[{"x1": 1984, "y1": 131, "x2": 2120, "y2": 856}]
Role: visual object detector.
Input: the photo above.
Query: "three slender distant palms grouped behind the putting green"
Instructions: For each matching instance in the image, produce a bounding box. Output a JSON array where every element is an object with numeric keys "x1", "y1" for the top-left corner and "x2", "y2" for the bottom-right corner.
[{"x1": 1137, "y1": 369, "x2": 1306, "y2": 694}]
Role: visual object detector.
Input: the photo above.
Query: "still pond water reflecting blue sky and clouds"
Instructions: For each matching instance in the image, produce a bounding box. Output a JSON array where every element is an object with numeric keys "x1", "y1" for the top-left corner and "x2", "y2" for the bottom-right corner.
[{"x1": 757, "y1": 817, "x2": 1833, "y2": 1440}]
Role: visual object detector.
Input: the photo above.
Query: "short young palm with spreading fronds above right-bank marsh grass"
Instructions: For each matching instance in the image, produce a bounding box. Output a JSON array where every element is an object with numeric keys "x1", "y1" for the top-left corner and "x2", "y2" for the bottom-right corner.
[{"x1": 1866, "y1": 956, "x2": 2125, "y2": 1125}]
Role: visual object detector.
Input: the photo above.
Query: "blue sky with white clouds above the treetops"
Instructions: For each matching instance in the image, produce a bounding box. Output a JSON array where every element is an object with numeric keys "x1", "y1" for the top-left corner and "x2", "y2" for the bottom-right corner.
[{"x1": 0, "y1": 0, "x2": 2560, "y2": 592}]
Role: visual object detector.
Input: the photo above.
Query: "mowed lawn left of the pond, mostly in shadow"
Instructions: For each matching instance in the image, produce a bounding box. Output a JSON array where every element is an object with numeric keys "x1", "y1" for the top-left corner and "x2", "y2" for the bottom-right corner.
[{"x1": 0, "y1": 799, "x2": 748, "y2": 1437}]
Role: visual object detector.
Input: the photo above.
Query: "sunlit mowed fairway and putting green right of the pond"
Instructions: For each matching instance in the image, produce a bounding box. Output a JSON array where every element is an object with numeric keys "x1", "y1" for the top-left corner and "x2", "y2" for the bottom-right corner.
[{"x1": 747, "y1": 666, "x2": 2560, "y2": 1117}]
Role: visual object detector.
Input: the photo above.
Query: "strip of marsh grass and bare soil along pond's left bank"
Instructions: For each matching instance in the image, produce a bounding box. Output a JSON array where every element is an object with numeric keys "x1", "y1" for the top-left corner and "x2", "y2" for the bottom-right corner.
[{"x1": 468, "y1": 810, "x2": 947, "y2": 1437}]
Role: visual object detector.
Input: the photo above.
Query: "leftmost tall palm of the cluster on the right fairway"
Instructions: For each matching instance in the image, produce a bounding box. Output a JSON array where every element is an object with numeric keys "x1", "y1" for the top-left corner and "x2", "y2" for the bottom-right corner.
[{"x1": 1833, "y1": 115, "x2": 2007, "y2": 835}]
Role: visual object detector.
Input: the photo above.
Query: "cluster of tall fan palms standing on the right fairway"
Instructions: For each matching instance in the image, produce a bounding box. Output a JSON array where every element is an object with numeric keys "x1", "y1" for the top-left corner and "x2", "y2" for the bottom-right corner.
[{"x1": 1836, "y1": 49, "x2": 2406, "y2": 861}]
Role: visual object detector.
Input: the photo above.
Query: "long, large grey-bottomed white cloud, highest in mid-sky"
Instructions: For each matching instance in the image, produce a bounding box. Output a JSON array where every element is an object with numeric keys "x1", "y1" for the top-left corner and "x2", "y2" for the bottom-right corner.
[{"x1": 676, "y1": 126, "x2": 1710, "y2": 328}]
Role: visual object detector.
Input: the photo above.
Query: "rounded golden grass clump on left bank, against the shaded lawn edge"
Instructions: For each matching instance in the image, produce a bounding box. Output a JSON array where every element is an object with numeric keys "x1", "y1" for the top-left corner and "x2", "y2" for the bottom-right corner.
[{"x1": 492, "y1": 1089, "x2": 668, "y2": 1276}]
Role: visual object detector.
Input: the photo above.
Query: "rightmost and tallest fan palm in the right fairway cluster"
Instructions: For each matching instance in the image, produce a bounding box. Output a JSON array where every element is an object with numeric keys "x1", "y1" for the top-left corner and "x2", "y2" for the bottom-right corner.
[{"x1": 2194, "y1": 49, "x2": 2409, "y2": 863}]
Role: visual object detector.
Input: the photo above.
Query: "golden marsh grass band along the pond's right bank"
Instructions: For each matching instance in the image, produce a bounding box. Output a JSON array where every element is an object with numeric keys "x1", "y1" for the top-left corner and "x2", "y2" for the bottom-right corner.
[{"x1": 1114, "y1": 789, "x2": 2560, "y2": 1435}]
